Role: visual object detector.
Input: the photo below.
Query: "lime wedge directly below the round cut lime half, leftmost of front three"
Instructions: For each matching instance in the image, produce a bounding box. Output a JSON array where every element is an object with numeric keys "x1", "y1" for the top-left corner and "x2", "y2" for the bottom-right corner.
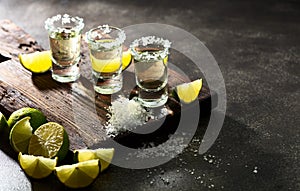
[{"x1": 18, "y1": 153, "x2": 57, "y2": 179}]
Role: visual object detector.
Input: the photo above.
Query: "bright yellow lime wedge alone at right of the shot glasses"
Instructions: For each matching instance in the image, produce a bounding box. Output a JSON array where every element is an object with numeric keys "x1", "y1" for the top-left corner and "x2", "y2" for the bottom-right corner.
[{"x1": 175, "y1": 79, "x2": 202, "y2": 103}]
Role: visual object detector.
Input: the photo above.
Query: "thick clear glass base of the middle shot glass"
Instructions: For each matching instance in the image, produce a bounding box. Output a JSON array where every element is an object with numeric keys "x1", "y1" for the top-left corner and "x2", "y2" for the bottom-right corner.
[{"x1": 94, "y1": 74, "x2": 123, "y2": 94}]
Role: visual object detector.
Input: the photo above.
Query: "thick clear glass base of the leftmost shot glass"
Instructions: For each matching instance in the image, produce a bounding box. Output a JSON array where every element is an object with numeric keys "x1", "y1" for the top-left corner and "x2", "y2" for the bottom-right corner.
[{"x1": 51, "y1": 63, "x2": 80, "y2": 83}]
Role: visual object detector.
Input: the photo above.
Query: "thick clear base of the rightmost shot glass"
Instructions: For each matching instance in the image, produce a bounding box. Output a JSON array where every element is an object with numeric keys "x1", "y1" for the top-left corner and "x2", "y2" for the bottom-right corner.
[{"x1": 138, "y1": 87, "x2": 168, "y2": 108}]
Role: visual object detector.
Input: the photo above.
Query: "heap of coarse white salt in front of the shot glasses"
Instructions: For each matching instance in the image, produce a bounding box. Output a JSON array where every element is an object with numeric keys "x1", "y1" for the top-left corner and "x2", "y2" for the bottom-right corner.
[{"x1": 105, "y1": 96, "x2": 167, "y2": 137}]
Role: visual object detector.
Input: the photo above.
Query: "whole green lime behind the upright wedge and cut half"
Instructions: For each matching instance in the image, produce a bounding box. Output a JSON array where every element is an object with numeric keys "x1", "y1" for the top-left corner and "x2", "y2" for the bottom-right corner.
[{"x1": 7, "y1": 107, "x2": 47, "y2": 130}]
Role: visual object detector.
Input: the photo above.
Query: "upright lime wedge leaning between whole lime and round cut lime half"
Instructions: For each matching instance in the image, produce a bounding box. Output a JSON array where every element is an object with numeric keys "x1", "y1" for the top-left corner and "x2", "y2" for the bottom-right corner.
[{"x1": 9, "y1": 117, "x2": 32, "y2": 153}]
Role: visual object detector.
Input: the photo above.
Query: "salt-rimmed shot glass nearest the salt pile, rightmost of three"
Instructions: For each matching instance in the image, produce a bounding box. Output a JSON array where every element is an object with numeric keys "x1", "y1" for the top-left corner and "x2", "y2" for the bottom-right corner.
[{"x1": 130, "y1": 36, "x2": 171, "y2": 108}]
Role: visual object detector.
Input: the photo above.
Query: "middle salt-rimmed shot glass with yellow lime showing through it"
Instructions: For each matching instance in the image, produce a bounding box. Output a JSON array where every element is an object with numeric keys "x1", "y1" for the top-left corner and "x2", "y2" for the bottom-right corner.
[{"x1": 86, "y1": 25, "x2": 126, "y2": 94}]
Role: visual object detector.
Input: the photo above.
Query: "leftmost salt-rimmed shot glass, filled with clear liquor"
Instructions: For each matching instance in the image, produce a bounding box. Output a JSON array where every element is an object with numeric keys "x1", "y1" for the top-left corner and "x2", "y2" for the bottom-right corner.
[{"x1": 45, "y1": 14, "x2": 84, "y2": 83}]
